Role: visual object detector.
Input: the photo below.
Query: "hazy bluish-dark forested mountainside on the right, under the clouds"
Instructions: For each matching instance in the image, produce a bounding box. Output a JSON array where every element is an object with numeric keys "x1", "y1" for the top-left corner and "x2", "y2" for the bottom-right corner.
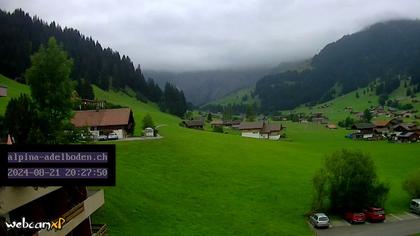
[{"x1": 255, "y1": 20, "x2": 420, "y2": 111}]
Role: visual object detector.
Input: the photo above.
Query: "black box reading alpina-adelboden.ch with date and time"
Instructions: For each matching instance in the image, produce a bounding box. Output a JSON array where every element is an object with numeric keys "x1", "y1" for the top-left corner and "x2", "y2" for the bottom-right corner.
[{"x1": 0, "y1": 145, "x2": 116, "y2": 186}]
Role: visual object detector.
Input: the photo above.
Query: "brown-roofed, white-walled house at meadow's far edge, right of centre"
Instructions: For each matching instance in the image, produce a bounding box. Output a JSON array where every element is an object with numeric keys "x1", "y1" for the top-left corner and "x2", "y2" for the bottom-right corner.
[{"x1": 239, "y1": 121, "x2": 284, "y2": 140}]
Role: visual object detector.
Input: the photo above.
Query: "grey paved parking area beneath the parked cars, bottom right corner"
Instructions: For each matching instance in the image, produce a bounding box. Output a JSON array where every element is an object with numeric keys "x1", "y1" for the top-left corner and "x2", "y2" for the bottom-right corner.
[{"x1": 311, "y1": 212, "x2": 420, "y2": 236}]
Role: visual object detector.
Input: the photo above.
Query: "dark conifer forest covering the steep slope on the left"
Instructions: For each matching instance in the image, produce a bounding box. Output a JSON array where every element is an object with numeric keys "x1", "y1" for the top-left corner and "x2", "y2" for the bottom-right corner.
[{"x1": 0, "y1": 9, "x2": 187, "y2": 115}]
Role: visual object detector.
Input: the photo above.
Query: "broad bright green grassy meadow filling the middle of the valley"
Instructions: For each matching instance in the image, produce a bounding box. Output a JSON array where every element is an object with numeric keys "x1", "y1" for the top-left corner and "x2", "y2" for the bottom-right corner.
[{"x1": 0, "y1": 77, "x2": 420, "y2": 235}]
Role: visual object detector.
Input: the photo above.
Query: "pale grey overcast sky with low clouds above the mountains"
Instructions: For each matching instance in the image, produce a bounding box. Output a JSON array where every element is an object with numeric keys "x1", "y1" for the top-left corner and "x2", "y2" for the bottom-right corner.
[{"x1": 0, "y1": 0, "x2": 420, "y2": 71}]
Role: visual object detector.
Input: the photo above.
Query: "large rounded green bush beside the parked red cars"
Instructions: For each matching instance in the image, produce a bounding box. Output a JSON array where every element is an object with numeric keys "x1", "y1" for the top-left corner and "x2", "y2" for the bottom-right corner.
[{"x1": 312, "y1": 149, "x2": 389, "y2": 214}]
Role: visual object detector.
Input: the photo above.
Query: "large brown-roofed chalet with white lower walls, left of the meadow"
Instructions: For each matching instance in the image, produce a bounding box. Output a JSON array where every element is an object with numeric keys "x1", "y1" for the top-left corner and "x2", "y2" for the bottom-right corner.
[{"x1": 71, "y1": 108, "x2": 134, "y2": 139}]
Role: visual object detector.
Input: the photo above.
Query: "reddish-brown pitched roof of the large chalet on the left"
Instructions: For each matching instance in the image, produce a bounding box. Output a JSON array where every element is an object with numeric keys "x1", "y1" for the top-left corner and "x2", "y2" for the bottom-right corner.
[{"x1": 71, "y1": 108, "x2": 133, "y2": 127}]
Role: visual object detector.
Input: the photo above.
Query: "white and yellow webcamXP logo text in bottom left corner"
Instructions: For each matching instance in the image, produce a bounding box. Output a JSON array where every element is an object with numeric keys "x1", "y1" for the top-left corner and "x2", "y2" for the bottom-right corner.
[{"x1": 4, "y1": 217, "x2": 66, "y2": 230}]
